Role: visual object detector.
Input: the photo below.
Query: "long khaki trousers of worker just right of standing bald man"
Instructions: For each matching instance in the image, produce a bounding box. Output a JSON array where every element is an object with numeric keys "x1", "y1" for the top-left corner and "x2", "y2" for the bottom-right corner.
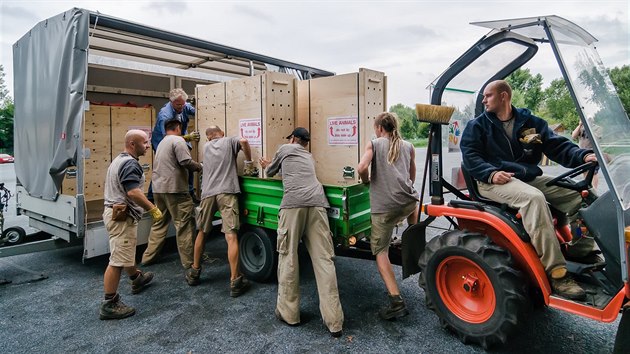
[{"x1": 142, "y1": 193, "x2": 195, "y2": 269}]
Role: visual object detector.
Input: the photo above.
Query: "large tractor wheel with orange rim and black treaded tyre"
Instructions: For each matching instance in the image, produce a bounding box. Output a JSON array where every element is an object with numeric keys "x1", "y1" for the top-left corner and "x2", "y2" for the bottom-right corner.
[{"x1": 418, "y1": 230, "x2": 527, "y2": 349}]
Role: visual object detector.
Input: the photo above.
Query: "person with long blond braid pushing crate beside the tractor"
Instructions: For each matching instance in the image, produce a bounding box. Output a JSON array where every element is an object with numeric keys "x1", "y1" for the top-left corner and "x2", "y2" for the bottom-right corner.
[{"x1": 357, "y1": 112, "x2": 418, "y2": 320}]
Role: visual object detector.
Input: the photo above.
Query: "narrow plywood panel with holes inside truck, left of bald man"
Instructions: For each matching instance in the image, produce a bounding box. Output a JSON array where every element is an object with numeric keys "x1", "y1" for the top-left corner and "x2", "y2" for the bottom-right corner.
[{"x1": 62, "y1": 105, "x2": 112, "y2": 201}]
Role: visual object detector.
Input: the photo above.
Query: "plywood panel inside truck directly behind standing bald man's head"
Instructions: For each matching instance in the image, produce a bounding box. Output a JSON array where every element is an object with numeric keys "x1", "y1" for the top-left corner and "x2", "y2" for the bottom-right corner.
[{"x1": 111, "y1": 107, "x2": 155, "y2": 193}]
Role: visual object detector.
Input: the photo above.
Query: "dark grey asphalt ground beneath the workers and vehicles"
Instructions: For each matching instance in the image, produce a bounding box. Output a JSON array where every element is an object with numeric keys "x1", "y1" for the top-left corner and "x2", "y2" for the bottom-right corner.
[{"x1": 0, "y1": 152, "x2": 618, "y2": 353}]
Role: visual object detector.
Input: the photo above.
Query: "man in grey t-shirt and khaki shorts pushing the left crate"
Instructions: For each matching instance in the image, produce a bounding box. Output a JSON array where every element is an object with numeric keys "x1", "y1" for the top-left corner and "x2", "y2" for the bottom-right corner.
[{"x1": 186, "y1": 125, "x2": 253, "y2": 297}]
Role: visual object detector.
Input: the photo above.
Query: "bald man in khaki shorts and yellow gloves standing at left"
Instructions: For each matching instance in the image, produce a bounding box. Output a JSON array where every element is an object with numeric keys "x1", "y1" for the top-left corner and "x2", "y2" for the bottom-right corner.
[{"x1": 99, "y1": 130, "x2": 162, "y2": 320}]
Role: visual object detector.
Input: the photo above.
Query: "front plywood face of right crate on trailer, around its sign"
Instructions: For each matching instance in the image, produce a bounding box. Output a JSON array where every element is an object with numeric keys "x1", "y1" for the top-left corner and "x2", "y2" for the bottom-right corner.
[{"x1": 309, "y1": 73, "x2": 360, "y2": 185}]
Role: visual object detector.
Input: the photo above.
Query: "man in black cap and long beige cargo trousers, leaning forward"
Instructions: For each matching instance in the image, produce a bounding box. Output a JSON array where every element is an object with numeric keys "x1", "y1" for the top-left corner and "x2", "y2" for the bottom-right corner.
[{"x1": 260, "y1": 128, "x2": 344, "y2": 337}]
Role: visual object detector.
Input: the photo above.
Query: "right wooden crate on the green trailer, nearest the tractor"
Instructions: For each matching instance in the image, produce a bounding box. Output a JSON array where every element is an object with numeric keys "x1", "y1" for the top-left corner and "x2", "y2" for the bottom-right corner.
[{"x1": 296, "y1": 69, "x2": 387, "y2": 185}]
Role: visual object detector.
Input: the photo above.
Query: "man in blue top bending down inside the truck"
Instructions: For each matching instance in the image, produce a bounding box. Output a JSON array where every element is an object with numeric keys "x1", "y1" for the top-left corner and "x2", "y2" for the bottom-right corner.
[{"x1": 149, "y1": 88, "x2": 200, "y2": 201}]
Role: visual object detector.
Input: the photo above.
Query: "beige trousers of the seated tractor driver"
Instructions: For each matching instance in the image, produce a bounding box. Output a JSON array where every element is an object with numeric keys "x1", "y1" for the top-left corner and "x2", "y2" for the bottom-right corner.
[{"x1": 477, "y1": 175, "x2": 582, "y2": 274}]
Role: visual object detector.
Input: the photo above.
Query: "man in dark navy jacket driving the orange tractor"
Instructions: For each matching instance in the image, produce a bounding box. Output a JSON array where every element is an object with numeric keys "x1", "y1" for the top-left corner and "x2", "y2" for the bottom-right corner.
[{"x1": 461, "y1": 80, "x2": 597, "y2": 300}]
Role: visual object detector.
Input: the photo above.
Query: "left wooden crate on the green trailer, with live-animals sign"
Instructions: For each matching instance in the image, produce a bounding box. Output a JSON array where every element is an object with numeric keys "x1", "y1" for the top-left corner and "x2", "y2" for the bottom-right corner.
[{"x1": 197, "y1": 72, "x2": 295, "y2": 174}]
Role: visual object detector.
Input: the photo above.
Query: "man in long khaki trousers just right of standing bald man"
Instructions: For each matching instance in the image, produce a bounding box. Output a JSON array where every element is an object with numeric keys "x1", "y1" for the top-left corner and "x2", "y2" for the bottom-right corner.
[{"x1": 142, "y1": 119, "x2": 201, "y2": 269}]
